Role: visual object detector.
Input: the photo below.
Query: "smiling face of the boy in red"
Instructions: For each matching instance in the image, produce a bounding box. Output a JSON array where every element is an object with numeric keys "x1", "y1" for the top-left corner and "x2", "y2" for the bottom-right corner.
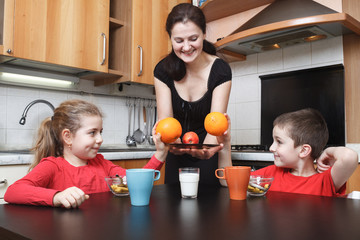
[{"x1": 270, "y1": 126, "x2": 301, "y2": 168}]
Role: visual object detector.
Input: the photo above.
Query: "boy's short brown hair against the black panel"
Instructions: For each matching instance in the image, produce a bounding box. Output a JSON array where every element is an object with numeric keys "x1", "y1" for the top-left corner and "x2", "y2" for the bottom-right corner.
[{"x1": 273, "y1": 108, "x2": 329, "y2": 159}]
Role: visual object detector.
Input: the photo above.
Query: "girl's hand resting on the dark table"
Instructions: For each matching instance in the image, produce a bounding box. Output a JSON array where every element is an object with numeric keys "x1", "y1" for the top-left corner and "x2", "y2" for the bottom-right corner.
[{"x1": 53, "y1": 187, "x2": 89, "y2": 209}]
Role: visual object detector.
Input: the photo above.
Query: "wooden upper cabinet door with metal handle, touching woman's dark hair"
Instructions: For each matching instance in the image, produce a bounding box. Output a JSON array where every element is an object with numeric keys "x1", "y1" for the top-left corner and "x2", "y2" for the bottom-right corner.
[{"x1": 131, "y1": 0, "x2": 190, "y2": 85}]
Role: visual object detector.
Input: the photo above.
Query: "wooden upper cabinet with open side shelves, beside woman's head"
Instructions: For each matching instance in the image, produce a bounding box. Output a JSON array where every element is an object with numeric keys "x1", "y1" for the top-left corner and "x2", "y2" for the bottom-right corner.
[{"x1": 95, "y1": 0, "x2": 190, "y2": 85}]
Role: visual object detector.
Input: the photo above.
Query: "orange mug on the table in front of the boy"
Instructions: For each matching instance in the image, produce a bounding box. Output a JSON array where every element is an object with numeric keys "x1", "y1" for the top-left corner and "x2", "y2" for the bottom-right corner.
[{"x1": 215, "y1": 166, "x2": 251, "y2": 200}]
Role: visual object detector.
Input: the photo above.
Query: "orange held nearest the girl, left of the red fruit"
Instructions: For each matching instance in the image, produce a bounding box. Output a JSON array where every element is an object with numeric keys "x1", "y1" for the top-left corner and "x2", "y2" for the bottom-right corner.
[{"x1": 155, "y1": 117, "x2": 182, "y2": 143}]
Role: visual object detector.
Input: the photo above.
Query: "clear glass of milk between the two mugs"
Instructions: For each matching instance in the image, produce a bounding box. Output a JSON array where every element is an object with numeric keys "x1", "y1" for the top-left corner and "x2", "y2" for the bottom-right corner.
[{"x1": 179, "y1": 167, "x2": 200, "y2": 198}]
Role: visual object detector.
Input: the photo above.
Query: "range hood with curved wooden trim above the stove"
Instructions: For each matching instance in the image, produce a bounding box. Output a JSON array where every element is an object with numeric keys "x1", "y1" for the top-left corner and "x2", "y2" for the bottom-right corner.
[{"x1": 215, "y1": 0, "x2": 360, "y2": 55}]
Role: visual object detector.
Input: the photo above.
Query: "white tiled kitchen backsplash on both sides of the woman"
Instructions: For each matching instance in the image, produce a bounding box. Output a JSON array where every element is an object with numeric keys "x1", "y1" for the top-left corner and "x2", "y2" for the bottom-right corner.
[{"x1": 0, "y1": 37, "x2": 343, "y2": 149}]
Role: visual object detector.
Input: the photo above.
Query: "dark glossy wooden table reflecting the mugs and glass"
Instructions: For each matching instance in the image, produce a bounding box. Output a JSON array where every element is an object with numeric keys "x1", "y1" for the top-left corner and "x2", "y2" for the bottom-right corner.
[{"x1": 0, "y1": 185, "x2": 360, "y2": 240}]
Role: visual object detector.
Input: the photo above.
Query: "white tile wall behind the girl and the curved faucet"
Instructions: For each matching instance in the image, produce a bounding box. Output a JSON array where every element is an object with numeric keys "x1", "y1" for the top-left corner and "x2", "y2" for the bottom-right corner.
[{"x1": 0, "y1": 80, "x2": 154, "y2": 149}]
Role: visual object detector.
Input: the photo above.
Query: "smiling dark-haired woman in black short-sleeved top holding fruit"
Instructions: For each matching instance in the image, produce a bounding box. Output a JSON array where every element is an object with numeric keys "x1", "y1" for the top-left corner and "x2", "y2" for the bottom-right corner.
[{"x1": 154, "y1": 3, "x2": 232, "y2": 185}]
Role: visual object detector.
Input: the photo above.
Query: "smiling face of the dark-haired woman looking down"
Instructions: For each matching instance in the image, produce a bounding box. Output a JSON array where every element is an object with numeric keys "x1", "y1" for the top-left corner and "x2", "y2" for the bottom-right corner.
[{"x1": 171, "y1": 21, "x2": 205, "y2": 63}]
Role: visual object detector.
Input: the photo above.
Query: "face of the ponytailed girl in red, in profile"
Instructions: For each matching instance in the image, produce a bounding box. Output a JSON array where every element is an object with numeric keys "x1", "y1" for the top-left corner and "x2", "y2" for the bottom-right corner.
[{"x1": 71, "y1": 116, "x2": 103, "y2": 160}]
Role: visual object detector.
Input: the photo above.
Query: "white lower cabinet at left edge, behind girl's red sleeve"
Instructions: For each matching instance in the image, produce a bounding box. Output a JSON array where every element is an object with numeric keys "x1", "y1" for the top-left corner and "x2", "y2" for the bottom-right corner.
[{"x1": 0, "y1": 165, "x2": 30, "y2": 204}]
